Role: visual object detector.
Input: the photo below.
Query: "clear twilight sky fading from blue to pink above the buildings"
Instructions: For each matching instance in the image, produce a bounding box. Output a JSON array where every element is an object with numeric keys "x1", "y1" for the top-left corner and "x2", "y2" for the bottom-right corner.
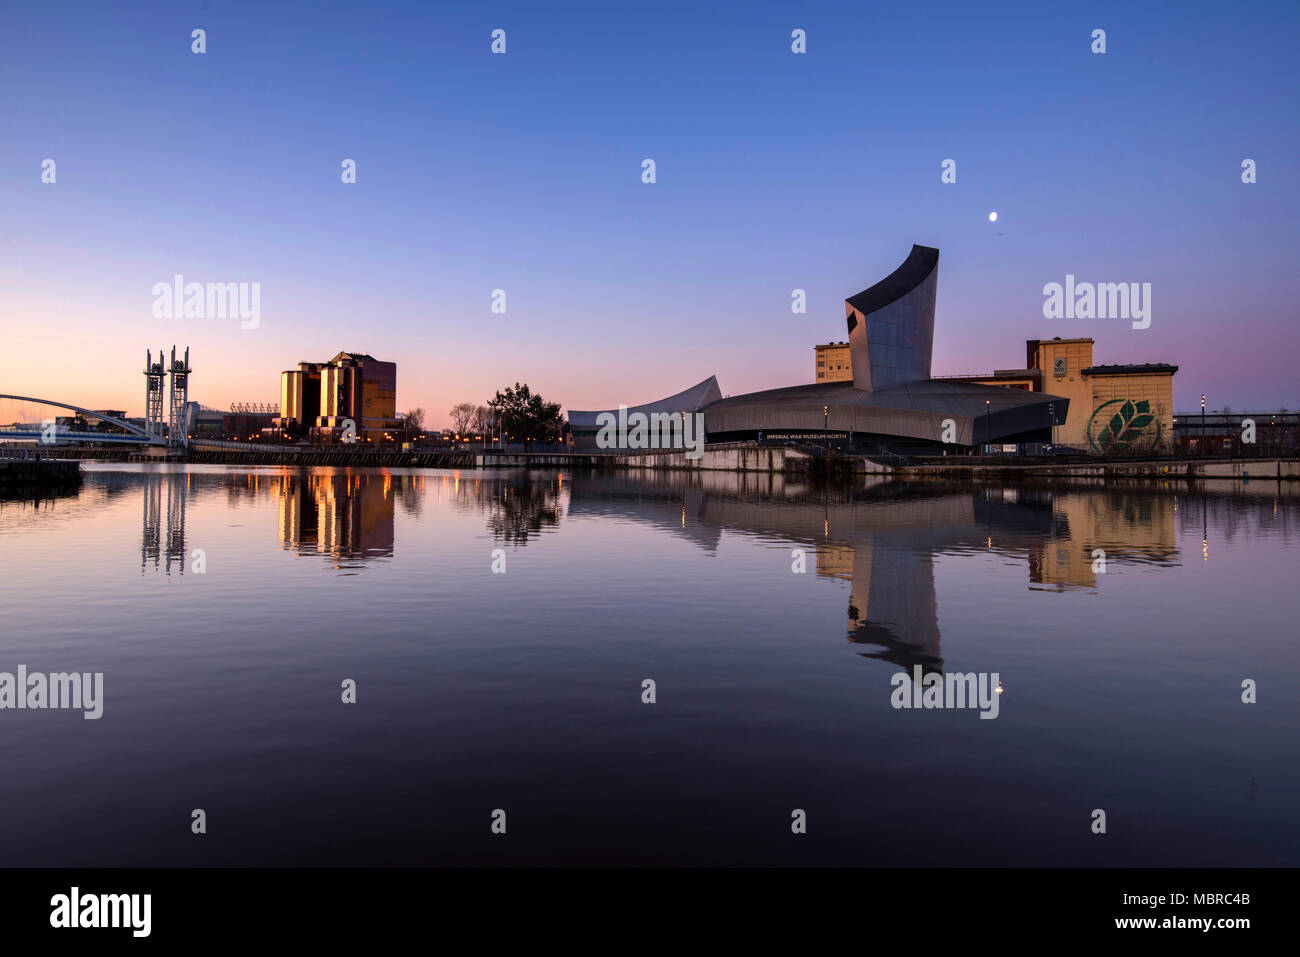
[{"x1": 0, "y1": 0, "x2": 1300, "y2": 425}]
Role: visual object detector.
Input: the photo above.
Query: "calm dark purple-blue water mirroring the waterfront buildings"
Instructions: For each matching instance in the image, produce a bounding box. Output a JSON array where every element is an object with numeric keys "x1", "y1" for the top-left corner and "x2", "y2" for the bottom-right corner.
[{"x1": 0, "y1": 464, "x2": 1300, "y2": 866}]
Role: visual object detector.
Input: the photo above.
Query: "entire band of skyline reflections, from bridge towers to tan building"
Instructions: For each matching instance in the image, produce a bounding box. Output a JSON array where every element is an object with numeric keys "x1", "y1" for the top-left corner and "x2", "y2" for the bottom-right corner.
[{"x1": 131, "y1": 469, "x2": 1196, "y2": 671}]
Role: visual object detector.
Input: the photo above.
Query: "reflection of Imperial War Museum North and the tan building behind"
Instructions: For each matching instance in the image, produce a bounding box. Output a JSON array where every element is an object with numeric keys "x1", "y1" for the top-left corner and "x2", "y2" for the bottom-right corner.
[{"x1": 569, "y1": 472, "x2": 1178, "y2": 672}]
